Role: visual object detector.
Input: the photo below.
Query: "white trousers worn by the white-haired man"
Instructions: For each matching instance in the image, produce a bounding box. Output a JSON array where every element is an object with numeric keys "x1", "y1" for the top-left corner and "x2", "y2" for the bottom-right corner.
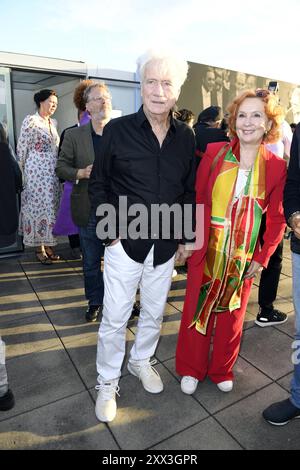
[{"x1": 97, "y1": 242, "x2": 175, "y2": 382}]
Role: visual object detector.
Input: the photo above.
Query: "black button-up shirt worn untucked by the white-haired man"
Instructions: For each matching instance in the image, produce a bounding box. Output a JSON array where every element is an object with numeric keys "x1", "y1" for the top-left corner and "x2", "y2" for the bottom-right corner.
[{"x1": 89, "y1": 107, "x2": 195, "y2": 265}]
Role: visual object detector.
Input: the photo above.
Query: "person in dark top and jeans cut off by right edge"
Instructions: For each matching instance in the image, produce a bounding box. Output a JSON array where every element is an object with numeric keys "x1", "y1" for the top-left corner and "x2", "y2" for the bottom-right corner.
[{"x1": 263, "y1": 124, "x2": 300, "y2": 426}]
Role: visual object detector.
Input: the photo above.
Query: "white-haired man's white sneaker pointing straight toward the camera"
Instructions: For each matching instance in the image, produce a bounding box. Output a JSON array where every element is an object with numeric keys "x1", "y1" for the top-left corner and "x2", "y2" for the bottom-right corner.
[{"x1": 95, "y1": 379, "x2": 120, "y2": 423}]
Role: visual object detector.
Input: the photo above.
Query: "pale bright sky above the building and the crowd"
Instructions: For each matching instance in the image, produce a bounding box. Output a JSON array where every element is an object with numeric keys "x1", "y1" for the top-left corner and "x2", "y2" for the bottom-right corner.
[{"x1": 0, "y1": 0, "x2": 300, "y2": 83}]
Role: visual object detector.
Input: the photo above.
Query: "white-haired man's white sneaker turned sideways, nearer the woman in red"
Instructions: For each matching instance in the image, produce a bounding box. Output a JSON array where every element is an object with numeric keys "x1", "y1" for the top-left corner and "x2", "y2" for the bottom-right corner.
[{"x1": 127, "y1": 359, "x2": 164, "y2": 393}]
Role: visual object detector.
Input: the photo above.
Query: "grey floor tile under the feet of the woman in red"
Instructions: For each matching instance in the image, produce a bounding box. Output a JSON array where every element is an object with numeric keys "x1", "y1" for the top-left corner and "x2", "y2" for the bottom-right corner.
[{"x1": 163, "y1": 357, "x2": 272, "y2": 414}]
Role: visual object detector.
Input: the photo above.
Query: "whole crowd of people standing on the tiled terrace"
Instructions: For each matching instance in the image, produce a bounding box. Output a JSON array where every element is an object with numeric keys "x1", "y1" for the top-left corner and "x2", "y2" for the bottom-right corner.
[{"x1": 0, "y1": 51, "x2": 300, "y2": 425}]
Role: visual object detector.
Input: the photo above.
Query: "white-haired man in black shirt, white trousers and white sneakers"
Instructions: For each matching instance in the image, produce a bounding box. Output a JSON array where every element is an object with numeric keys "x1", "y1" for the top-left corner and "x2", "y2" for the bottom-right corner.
[{"x1": 89, "y1": 52, "x2": 195, "y2": 422}]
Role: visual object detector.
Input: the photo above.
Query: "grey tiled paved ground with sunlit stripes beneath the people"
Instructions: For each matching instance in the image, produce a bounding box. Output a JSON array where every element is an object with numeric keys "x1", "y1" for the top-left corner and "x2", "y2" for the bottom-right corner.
[{"x1": 0, "y1": 244, "x2": 300, "y2": 450}]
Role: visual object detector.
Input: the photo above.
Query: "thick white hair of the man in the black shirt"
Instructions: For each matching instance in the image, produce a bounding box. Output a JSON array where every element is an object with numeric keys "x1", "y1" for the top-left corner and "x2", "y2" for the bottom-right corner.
[{"x1": 137, "y1": 49, "x2": 189, "y2": 90}]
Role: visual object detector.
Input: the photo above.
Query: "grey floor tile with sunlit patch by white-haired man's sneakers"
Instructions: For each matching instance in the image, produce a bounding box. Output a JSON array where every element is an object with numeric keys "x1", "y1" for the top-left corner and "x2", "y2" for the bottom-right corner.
[{"x1": 94, "y1": 366, "x2": 208, "y2": 449}]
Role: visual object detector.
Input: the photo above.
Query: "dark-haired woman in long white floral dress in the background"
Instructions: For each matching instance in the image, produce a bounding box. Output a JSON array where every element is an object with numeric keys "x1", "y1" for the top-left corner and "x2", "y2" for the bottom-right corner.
[{"x1": 17, "y1": 90, "x2": 60, "y2": 264}]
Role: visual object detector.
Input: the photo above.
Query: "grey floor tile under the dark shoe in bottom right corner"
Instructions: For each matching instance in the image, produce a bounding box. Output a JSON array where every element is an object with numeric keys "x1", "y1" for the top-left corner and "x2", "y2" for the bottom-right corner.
[{"x1": 215, "y1": 384, "x2": 300, "y2": 450}]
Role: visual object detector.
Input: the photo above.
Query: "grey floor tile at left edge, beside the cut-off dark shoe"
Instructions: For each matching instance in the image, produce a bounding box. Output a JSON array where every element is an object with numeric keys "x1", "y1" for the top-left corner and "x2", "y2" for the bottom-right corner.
[{"x1": 0, "y1": 348, "x2": 85, "y2": 421}]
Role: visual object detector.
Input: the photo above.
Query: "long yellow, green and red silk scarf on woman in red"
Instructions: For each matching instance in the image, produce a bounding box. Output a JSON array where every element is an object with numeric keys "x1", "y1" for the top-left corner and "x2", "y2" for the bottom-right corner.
[{"x1": 190, "y1": 145, "x2": 266, "y2": 334}]
